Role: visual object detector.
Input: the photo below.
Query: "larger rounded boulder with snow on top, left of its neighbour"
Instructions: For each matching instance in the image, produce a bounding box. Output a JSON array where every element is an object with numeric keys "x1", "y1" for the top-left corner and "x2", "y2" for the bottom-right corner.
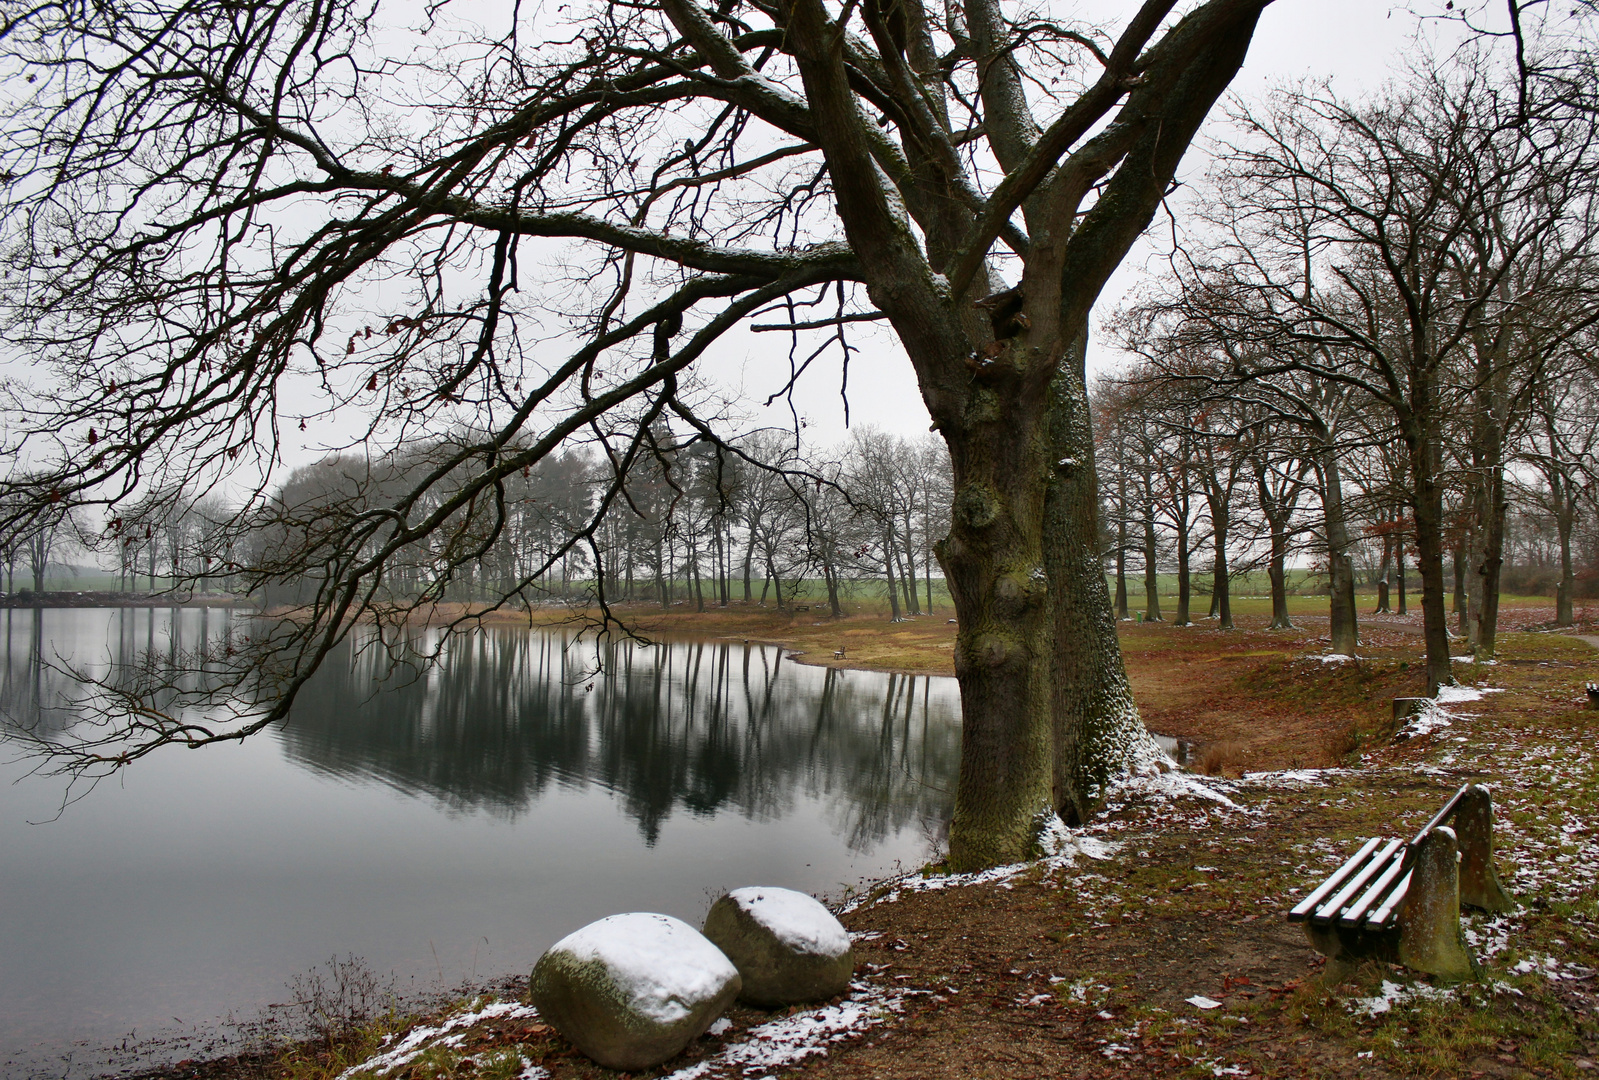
[{"x1": 529, "y1": 912, "x2": 742, "y2": 1070}]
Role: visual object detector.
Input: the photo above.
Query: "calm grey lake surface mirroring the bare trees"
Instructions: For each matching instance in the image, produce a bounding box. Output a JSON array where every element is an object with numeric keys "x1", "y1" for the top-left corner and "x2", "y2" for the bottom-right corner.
[{"x1": 0, "y1": 610, "x2": 959, "y2": 1077}]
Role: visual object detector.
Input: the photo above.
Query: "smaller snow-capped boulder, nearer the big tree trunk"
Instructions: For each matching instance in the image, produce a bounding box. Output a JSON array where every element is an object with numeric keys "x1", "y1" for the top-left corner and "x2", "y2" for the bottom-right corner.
[{"x1": 705, "y1": 888, "x2": 855, "y2": 1008}]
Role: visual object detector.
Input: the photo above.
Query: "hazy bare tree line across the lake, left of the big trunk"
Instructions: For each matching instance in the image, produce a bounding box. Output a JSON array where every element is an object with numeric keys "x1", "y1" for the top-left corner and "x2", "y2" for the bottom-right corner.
[{"x1": 50, "y1": 424, "x2": 951, "y2": 619}]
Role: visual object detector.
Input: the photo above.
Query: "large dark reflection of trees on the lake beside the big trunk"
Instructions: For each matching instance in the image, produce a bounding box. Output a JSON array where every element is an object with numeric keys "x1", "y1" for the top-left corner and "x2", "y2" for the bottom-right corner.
[{"x1": 283, "y1": 629, "x2": 959, "y2": 850}]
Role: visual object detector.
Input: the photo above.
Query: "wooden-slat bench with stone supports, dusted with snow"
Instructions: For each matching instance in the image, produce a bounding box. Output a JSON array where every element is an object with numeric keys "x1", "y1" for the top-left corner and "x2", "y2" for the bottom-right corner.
[{"x1": 1289, "y1": 784, "x2": 1514, "y2": 982}]
